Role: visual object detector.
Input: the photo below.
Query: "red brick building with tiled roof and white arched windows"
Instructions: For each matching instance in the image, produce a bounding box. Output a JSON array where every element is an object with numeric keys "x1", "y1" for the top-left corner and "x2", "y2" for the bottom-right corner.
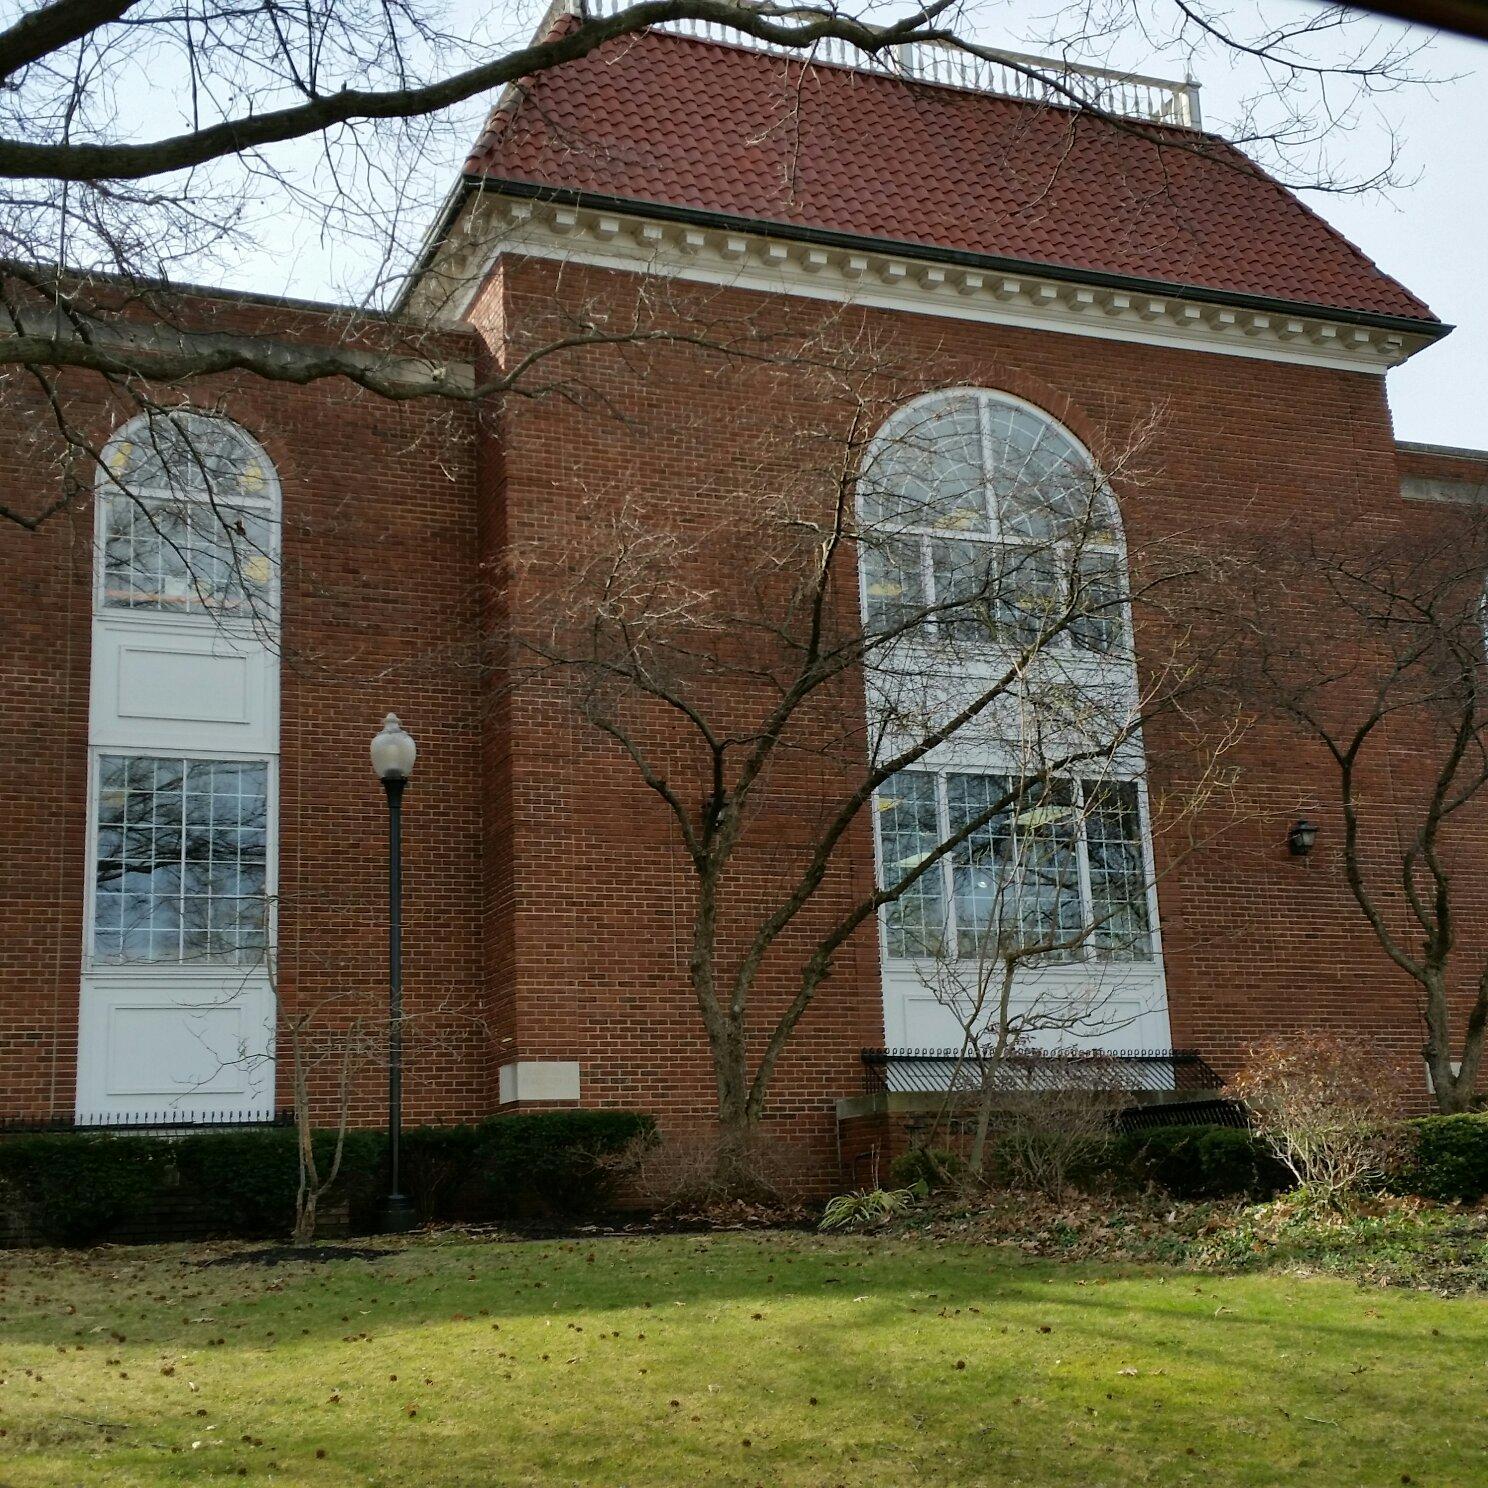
[{"x1": 0, "y1": 8, "x2": 1488, "y2": 1170}]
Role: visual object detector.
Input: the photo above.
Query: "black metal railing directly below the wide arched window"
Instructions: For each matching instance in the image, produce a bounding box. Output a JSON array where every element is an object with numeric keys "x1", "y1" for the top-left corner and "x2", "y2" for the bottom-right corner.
[{"x1": 862, "y1": 1049, "x2": 1223, "y2": 1095}]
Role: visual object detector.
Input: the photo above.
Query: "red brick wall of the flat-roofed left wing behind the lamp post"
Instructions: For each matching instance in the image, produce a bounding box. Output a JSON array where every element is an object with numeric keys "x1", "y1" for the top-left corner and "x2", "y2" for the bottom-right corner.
[{"x1": 0, "y1": 290, "x2": 490, "y2": 1120}]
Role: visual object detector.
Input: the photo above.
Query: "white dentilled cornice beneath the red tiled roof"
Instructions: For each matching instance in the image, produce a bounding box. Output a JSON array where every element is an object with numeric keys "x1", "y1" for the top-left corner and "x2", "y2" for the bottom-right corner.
[{"x1": 432, "y1": 190, "x2": 1433, "y2": 373}]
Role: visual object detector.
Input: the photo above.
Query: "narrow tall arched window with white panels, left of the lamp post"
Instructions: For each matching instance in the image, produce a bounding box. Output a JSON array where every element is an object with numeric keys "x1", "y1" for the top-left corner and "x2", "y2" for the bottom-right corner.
[{"x1": 77, "y1": 409, "x2": 280, "y2": 1115}]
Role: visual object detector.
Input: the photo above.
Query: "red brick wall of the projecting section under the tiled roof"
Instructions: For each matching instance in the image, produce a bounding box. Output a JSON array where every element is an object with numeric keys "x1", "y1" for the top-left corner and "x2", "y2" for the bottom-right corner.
[{"x1": 473, "y1": 252, "x2": 1476, "y2": 1152}]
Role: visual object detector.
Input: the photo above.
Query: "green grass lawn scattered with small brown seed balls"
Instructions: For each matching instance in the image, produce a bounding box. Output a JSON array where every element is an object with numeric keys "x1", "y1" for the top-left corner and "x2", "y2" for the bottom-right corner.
[{"x1": 0, "y1": 1234, "x2": 1488, "y2": 1488}]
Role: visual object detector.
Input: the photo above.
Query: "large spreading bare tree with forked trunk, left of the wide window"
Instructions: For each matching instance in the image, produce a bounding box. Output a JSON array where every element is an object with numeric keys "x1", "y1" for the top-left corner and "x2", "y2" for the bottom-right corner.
[{"x1": 510, "y1": 337, "x2": 1220, "y2": 1174}]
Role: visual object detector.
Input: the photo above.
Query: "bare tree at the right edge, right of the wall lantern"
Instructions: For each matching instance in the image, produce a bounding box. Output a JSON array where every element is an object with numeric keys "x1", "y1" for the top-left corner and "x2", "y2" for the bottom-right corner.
[{"x1": 1244, "y1": 506, "x2": 1488, "y2": 1112}]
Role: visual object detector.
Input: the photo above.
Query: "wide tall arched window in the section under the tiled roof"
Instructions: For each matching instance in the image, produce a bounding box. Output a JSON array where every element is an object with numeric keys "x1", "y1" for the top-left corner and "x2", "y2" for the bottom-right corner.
[{"x1": 859, "y1": 388, "x2": 1165, "y2": 1045}]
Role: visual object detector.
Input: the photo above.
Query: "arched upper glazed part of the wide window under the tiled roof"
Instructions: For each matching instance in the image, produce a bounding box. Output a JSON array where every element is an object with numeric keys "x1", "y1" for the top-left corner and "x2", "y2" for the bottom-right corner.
[{"x1": 859, "y1": 390, "x2": 1126, "y2": 656}]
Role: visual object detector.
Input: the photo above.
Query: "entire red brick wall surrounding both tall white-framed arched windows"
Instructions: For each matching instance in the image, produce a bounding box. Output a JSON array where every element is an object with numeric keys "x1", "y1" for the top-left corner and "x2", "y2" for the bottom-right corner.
[{"x1": 0, "y1": 260, "x2": 1482, "y2": 1165}]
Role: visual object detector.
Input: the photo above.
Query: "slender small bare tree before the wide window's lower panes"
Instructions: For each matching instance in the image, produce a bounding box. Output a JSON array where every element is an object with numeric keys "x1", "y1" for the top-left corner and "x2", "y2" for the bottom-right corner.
[{"x1": 920, "y1": 749, "x2": 1235, "y2": 1178}]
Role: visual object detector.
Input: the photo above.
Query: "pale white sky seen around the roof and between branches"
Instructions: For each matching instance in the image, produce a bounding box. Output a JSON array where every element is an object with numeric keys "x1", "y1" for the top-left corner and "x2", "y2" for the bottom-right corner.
[{"x1": 216, "y1": 0, "x2": 1488, "y2": 448}]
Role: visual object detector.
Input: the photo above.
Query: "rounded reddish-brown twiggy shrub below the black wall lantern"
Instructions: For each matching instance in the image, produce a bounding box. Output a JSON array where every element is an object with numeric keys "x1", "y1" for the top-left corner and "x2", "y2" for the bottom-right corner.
[{"x1": 1231, "y1": 1033, "x2": 1399, "y2": 1204}]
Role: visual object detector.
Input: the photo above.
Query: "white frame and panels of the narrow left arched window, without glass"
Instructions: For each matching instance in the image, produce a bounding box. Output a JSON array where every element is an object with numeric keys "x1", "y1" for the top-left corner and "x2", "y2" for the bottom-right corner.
[{"x1": 76, "y1": 408, "x2": 283, "y2": 1116}]
